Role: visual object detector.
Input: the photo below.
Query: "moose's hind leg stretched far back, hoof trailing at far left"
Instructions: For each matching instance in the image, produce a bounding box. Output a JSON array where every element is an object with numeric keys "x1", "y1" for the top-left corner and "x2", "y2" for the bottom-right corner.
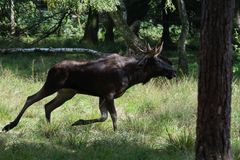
[{"x1": 2, "y1": 87, "x2": 55, "y2": 132}]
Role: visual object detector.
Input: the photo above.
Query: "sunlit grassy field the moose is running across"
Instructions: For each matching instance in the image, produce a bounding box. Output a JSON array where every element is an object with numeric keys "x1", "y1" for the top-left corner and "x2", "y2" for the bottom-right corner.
[{"x1": 0, "y1": 54, "x2": 240, "y2": 160}]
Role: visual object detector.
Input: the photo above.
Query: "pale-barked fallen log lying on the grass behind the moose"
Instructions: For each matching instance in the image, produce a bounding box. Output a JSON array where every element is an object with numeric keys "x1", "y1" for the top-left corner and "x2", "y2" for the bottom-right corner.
[{"x1": 0, "y1": 48, "x2": 105, "y2": 57}]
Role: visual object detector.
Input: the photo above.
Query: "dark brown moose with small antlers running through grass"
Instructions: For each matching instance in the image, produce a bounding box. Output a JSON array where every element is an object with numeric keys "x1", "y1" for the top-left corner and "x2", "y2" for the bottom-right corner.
[{"x1": 2, "y1": 42, "x2": 176, "y2": 132}]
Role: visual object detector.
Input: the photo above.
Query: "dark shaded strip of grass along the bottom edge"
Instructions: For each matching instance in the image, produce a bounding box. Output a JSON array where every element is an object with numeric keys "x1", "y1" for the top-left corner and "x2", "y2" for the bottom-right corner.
[{"x1": 0, "y1": 135, "x2": 191, "y2": 160}]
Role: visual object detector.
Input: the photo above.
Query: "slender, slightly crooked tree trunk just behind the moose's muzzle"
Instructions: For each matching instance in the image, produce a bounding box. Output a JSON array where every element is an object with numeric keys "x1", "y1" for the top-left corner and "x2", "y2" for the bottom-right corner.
[{"x1": 177, "y1": 0, "x2": 189, "y2": 74}]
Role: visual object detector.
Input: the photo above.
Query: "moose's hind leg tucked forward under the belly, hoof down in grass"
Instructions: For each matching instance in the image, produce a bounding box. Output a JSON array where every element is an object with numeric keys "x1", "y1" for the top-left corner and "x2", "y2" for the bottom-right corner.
[{"x1": 44, "y1": 89, "x2": 76, "y2": 122}]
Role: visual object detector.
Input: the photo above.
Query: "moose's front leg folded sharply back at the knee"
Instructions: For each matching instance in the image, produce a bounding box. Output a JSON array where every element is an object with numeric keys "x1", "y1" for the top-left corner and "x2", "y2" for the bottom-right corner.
[{"x1": 72, "y1": 98, "x2": 108, "y2": 126}]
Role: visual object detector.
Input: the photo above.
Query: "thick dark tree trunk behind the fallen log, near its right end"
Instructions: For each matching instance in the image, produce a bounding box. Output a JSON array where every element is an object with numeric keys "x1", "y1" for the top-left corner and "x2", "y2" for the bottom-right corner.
[{"x1": 82, "y1": 7, "x2": 99, "y2": 44}]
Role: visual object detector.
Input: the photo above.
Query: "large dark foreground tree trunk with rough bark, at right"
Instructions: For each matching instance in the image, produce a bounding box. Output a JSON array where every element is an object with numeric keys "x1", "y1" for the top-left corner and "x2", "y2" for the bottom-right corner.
[{"x1": 196, "y1": 0, "x2": 234, "y2": 160}]
